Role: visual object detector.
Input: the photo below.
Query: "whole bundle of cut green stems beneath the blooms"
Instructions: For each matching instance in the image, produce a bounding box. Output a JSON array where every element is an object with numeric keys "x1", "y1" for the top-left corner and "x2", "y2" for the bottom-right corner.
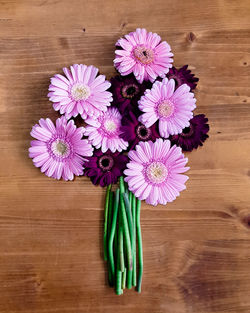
[{"x1": 103, "y1": 177, "x2": 143, "y2": 295}]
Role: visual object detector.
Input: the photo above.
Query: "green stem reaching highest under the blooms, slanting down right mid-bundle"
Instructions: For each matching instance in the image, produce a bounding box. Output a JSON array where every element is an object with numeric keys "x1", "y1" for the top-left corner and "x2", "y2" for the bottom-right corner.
[{"x1": 120, "y1": 176, "x2": 133, "y2": 289}]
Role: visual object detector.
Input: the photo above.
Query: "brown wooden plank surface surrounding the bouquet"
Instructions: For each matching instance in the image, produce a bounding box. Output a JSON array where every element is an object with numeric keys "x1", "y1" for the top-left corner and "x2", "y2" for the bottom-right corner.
[{"x1": 0, "y1": 0, "x2": 250, "y2": 313}]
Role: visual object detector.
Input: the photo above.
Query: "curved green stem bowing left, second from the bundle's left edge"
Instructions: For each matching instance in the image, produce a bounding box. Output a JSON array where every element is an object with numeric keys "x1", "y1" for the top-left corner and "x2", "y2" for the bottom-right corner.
[{"x1": 108, "y1": 189, "x2": 120, "y2": 282}]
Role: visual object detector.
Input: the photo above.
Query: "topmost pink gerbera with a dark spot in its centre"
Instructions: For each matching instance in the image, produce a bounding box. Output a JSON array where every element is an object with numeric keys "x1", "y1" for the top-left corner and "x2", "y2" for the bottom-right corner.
[{"x1": 114, "y1": 28, "x2": 173, "y2": 83}]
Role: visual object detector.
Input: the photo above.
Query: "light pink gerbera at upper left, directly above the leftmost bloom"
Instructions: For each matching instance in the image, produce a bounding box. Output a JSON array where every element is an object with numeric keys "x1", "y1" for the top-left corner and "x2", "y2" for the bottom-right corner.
[{"x1": 48, "y1": 64, "x2": 112, "y2": 119}]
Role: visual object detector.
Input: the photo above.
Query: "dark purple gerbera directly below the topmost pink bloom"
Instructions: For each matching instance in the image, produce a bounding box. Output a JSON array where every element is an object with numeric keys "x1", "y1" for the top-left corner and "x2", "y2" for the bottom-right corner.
[{"x1": 110, "y1": 75, "x2": 152, "y2": 114}]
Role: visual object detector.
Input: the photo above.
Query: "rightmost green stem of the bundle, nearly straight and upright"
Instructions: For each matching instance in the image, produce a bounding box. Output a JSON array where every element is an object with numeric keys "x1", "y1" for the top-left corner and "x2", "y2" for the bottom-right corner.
[{"x1": 136, "y1": 199, "x2": 143, "y2": 292}]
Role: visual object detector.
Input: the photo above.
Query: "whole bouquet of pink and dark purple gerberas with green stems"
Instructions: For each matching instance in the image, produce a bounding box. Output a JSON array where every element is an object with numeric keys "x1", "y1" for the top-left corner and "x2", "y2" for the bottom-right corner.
[{"x1": 29, "y1": 28, "x2": 209, "y2": 294}]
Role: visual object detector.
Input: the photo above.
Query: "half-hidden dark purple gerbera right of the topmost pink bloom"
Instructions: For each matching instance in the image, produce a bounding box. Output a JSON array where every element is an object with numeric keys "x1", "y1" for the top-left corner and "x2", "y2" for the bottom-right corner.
[{"x1": 167, "y1": 65, "x2": 199, "y2": 90}]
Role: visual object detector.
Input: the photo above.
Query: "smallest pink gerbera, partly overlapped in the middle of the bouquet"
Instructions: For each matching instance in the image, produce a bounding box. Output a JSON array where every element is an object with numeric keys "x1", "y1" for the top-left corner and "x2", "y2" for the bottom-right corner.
[{"x1": 85, "y1": 107, "x2": 128, "y2": 153}]
